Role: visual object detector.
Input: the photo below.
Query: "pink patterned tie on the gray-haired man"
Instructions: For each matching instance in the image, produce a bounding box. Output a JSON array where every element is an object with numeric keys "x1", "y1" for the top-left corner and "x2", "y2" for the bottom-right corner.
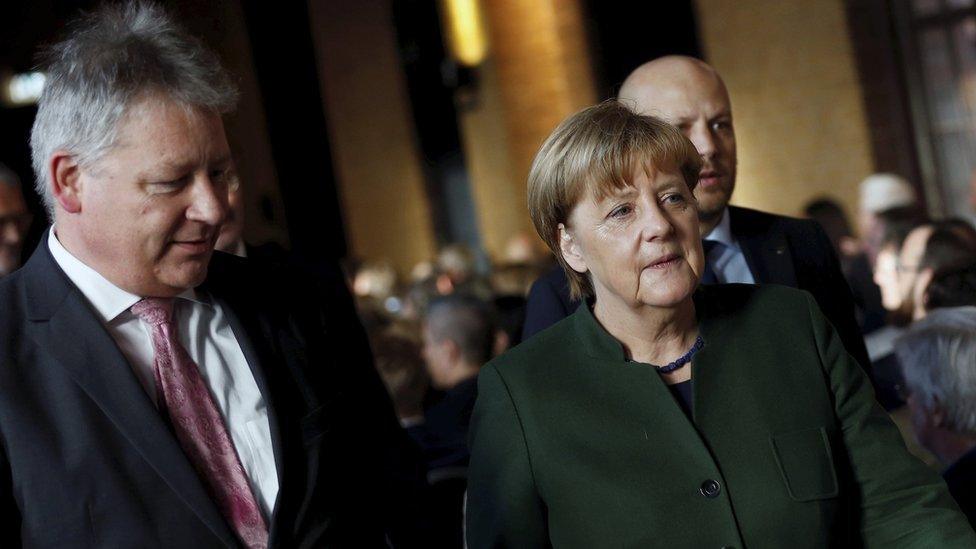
[{"x1": 132, "y1": 297, "x2": 268, "y2": 549}]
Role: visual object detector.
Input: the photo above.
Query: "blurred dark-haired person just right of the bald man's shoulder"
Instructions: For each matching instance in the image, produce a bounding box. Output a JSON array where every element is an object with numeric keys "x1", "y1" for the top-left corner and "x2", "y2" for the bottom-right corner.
[{"x1": 803, "y1": 198, "x2": 885, "y2": 334}]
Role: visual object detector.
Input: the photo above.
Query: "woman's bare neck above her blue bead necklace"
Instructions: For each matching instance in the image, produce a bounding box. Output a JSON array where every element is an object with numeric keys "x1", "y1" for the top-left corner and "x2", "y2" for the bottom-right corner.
[{"x1": 593, "y1": 296, "x2": 698, "y2": 366}]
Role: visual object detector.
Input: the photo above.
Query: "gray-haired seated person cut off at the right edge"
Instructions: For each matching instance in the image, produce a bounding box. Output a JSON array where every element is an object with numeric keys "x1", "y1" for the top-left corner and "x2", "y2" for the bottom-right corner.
[{"x1": 895, "y1": 307, "x2": 976, "y2": 526}]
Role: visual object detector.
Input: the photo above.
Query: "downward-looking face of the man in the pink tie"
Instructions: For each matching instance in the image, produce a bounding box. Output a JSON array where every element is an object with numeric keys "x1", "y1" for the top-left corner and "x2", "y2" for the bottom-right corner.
[{"x1": 68, "y1": 97, "x2": 234, "y2": 297}]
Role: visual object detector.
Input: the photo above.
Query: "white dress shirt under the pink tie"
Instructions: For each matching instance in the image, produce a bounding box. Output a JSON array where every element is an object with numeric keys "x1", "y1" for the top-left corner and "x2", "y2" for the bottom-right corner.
[{"x1": 48, "y1": 227, "x2": 278, "y2": 517}]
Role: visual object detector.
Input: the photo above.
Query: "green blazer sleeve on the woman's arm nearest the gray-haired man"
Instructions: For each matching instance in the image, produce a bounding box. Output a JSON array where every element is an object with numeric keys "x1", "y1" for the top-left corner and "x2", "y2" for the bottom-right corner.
[{"x1": 465, "y1": 364, "x2": 549, "y2": 549}]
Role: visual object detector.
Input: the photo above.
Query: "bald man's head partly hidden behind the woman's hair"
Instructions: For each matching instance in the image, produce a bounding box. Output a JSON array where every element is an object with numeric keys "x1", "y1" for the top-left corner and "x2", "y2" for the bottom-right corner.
[{"x1": 618, "y1": 55, "x2": 736, "y2": 235}]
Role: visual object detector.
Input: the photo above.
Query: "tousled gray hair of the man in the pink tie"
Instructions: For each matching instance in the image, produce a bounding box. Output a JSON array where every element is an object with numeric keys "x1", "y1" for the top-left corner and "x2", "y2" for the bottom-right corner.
[{"x1": 31, "y1": 2, "x2": 237, "y2": 220}]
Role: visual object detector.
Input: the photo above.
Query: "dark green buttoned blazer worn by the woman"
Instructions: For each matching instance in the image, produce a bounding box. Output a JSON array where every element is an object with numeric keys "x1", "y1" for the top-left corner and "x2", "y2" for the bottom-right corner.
[{"x1": 466, "y1": 284, "x2": 976, "y2": 549}]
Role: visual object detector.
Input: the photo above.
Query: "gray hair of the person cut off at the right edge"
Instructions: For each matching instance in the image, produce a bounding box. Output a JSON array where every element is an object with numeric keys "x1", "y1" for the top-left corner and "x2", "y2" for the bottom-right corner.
[{"x1": 895, "y1": 307, "x2": 976, "y2": 433}]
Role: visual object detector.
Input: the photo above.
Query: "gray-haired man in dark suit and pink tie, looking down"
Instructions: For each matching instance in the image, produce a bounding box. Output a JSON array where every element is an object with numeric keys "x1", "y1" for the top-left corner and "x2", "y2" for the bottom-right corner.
[{"x1": 0, "y1": 3, "x2": 422, "y2": 548}]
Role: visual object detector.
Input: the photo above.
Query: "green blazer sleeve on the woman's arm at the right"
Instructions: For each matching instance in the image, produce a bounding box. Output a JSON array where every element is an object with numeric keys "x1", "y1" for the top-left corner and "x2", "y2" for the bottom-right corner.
[{"x1": 807, "y1": 296, "x2": 976, "y2": 548}]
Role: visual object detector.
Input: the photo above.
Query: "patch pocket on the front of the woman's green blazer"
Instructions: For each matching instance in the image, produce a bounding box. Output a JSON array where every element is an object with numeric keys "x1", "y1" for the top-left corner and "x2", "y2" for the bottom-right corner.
[{"x1": 769, "y1": 427, "x2": 839, "y2": 501}]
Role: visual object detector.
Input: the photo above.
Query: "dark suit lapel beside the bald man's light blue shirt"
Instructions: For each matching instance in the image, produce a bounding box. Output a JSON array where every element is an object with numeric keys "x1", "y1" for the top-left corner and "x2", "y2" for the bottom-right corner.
[{"x1": 729, "y1": 206, "x2": 796, "y2": 287}]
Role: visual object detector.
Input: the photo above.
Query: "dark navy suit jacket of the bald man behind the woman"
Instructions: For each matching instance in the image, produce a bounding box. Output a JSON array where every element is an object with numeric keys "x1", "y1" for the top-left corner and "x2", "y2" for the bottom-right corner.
[{"x1": 523, "y1": 206, "x2": 871, "y2": 368}]
